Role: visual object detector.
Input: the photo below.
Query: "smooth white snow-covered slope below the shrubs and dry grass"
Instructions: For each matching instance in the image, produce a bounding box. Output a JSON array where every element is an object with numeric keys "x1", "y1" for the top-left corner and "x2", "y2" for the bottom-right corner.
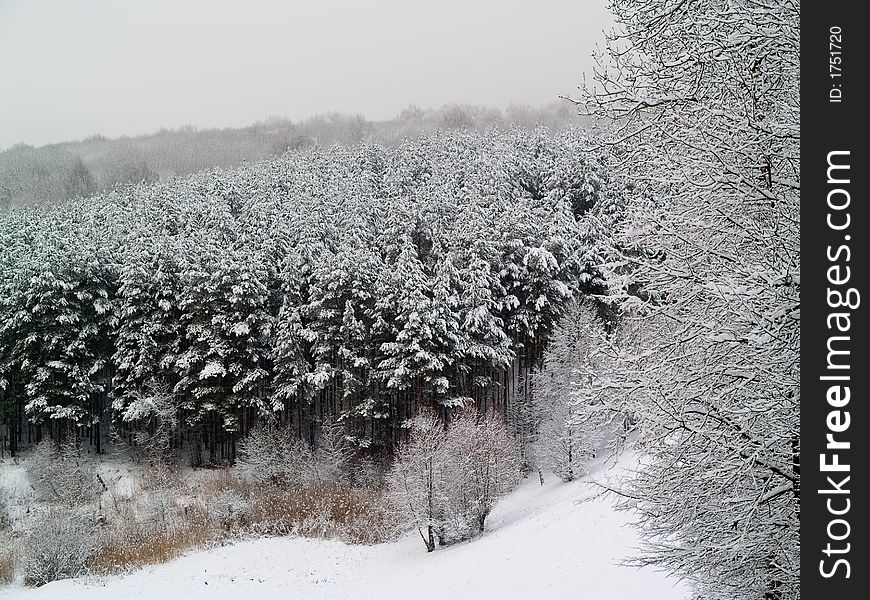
[{"x1": 0, "y1": 454, "x2": 689, "y2": 600}]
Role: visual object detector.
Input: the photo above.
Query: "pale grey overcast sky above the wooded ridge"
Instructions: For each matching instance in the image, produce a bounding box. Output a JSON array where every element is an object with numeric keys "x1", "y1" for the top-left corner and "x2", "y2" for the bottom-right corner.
[{"x1": 0, "y1": 0, "x2": 609, "y2": 148}]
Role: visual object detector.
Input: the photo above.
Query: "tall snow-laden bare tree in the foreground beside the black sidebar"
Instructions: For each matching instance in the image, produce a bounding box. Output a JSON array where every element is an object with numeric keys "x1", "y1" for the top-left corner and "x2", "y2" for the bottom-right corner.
[{"x1": 579, "y1": 0, "x2": 800, "y2": 598}]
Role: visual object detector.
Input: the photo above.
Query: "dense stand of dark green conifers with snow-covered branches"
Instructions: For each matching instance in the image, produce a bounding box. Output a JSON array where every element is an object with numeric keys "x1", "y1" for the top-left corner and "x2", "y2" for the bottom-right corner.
[{"x1": 0, "y1": 130, "x2": 622, "y2": 446}]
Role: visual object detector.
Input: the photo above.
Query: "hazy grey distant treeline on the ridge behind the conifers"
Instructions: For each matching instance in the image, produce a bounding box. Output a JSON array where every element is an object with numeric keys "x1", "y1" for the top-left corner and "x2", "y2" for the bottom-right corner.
[{"x1": 0, "y1": 103, "x2": 583, "y2": 210}]
